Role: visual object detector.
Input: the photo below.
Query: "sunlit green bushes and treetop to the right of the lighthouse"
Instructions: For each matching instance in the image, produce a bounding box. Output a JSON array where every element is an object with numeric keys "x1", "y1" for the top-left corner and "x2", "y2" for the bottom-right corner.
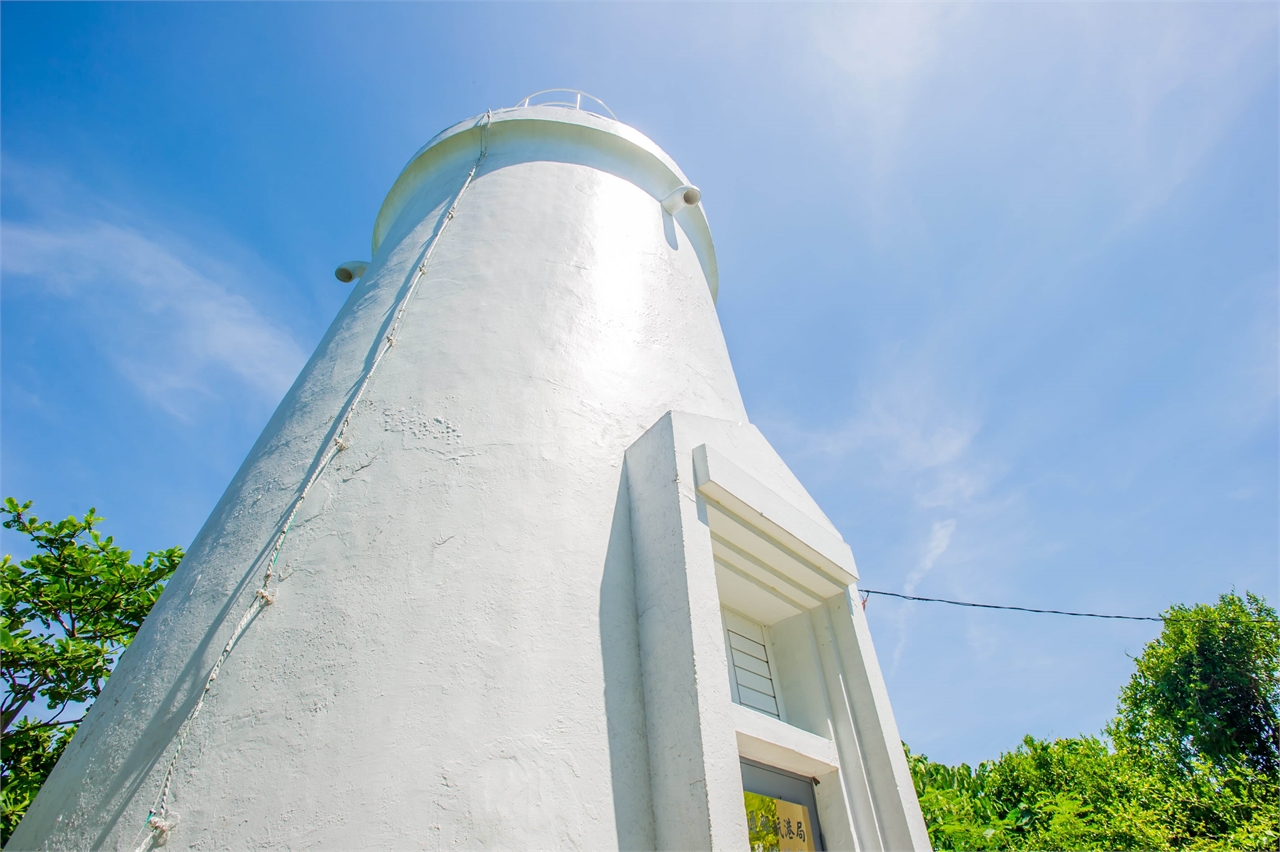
[{"x1": 908, "y1": 595, "x2": 1280, "y2": 849}]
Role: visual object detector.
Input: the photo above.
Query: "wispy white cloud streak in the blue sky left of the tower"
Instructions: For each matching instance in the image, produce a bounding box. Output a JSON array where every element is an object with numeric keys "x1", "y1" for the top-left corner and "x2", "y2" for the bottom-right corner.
[{"x1": 0, "y1": 184, "x2": 306, "y2": 420}]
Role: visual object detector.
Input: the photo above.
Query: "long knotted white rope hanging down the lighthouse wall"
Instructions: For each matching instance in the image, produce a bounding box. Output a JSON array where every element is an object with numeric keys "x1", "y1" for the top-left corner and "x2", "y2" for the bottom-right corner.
[{"x1": 137, "y1": 110, "x2": 493, "y2": 852}]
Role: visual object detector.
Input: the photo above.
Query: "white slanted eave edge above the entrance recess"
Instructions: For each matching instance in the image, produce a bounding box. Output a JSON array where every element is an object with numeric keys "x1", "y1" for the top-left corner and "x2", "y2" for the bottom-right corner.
[{"x1": 694, "y1": 444, "x2": 858, "y2": 586}]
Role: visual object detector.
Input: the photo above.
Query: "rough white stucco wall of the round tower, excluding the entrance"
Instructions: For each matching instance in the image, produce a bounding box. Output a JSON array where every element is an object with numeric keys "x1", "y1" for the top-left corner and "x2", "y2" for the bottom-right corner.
[{"x1": 9, "y1": 106, "x2": 746, "y2": 849}]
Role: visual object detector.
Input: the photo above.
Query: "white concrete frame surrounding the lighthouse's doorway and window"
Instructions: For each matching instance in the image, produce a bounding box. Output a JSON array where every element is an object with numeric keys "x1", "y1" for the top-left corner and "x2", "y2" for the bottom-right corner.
[{"x1": 626, "y1": 412, "x2": 929, "y2": 852}]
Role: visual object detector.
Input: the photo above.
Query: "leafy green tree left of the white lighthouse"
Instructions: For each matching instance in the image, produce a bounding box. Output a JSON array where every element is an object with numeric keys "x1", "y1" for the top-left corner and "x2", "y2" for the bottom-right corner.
[{"x1": 0, "y1": 498, "x2": 183, "y2": 843}]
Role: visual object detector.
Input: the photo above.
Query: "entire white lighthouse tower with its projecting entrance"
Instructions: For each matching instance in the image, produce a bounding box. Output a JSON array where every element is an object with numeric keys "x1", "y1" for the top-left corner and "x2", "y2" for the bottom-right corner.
[{"x1": 8, "y1": 93, "x2": 928, "y2": 852}]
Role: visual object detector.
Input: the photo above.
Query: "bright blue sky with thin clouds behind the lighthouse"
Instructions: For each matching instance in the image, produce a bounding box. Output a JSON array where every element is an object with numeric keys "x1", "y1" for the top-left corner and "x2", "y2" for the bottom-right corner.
[{"x1": 0, "y1": 3, "x2": 1280, "y2": 762}]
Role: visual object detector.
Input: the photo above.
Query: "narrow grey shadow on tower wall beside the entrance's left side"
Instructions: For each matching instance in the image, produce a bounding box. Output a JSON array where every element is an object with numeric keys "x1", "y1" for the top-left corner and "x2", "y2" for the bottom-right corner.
[{"x1": 600, "y1": 466, "x2": 657, "y2": 849}]
